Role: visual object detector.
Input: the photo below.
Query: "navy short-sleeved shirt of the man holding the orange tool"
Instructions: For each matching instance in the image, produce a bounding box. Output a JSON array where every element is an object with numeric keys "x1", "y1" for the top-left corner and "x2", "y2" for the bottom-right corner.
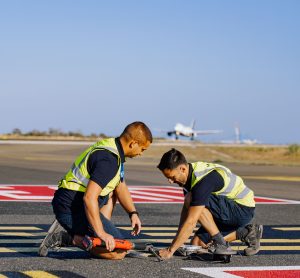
[{"x1": 52, "y1": 138, "x2": 125, "y2": 213}]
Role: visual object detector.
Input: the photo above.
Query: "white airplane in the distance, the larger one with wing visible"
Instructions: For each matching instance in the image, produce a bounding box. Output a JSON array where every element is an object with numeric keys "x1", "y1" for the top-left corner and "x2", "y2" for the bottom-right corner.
[{"x1": 167, "y1": 120, "x2": 222, "y2": 140}]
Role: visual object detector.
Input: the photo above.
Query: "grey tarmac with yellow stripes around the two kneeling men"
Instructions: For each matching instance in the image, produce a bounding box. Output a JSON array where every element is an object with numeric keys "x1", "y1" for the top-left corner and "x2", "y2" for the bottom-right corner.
[{"x1": 0, "y1": 144, "x2": 300, "y2": 277}]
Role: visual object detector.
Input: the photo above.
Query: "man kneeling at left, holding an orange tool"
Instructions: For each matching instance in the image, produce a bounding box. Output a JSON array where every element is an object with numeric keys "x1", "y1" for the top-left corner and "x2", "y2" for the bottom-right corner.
[{"x1": 39, "y1": 122, "x2": 152, "y2": 259}]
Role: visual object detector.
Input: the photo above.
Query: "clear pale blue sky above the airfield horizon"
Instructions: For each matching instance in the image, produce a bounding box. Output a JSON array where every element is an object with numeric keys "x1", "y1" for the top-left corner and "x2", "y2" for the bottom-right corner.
[{"x1": 0, "y1": 0, "x2": 300, "y2": 144}]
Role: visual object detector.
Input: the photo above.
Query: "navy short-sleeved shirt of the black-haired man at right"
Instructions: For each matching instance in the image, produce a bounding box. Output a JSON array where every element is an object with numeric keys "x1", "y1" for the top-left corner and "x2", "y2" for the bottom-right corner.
[{"x1": 184, "y1": 163, "x2": 224, "y2": 206}]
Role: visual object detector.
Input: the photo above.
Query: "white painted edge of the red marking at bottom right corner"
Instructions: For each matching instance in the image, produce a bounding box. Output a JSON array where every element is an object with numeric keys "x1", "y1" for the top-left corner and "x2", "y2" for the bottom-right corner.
[{"x1": 181, "y1": 265, "x2": 300, "y2": 278}]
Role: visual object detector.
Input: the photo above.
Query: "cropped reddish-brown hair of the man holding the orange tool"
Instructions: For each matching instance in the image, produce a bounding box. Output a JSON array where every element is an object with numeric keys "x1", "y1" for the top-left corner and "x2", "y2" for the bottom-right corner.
[{"x1": 120, "y1": 122, "x2": 153, "y2": 144}]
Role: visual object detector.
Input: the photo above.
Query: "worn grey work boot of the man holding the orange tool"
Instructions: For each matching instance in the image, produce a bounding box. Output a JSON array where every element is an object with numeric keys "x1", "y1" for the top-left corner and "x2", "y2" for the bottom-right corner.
[{"x1": 38, "y1": 220, "x2": 72, "y2": 257}]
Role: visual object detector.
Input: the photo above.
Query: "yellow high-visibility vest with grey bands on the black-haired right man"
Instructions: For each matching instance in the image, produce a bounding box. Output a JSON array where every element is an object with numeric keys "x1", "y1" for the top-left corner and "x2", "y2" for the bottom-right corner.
[{"x1": 191, "y1": 162, "x2": 255, "y2": 207}]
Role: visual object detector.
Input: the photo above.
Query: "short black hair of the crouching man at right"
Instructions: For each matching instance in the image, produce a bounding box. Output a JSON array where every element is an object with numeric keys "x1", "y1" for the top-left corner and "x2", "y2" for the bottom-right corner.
[{"x1": 157, "y1": 148, "x2": 188, "y2": 171}]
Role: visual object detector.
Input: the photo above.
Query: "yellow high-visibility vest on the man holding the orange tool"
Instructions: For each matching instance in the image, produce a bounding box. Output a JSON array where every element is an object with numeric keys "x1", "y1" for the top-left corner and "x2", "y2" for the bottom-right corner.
[{"x1": 58, "y1": 138, "x2": 124, "y2": 196}]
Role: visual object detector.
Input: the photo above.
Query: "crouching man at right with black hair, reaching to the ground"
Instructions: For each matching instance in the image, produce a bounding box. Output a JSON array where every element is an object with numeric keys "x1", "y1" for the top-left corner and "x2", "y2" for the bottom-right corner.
[{"x1": 157, "y1": 149, "x2": 263, "y2": 259}]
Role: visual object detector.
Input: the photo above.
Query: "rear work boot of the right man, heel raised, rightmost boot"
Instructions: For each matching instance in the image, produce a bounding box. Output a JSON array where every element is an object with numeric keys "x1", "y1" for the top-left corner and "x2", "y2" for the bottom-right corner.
[{"x1": 241, "y1": 224, "x2": 263, "y2": 256}]
